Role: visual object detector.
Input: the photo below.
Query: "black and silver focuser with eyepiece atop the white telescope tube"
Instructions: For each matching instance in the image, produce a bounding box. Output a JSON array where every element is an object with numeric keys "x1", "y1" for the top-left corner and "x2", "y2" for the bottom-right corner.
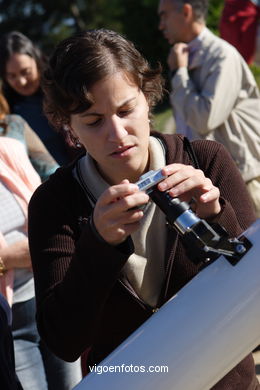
[{"x1": 136, "y1": 170, "x2": 252, "y2": 265}]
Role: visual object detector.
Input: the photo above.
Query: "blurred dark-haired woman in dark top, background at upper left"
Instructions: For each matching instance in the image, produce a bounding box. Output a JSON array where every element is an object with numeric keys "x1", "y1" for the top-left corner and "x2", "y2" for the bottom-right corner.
[{"x1": 0, "y1": 31, "x2": 80, "y2": 165}]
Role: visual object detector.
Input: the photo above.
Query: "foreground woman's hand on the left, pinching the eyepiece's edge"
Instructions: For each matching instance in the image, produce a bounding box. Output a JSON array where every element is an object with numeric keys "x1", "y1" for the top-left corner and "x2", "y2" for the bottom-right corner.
[{"x1": 93, "y1": 180, "x2": 149, "y2": 245}]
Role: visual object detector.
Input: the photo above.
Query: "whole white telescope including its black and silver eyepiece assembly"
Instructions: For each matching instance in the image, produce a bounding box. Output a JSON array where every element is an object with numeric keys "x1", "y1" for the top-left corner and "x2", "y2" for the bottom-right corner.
[{"x1": 74, "y1": 170, "x2": 260, "y2": 390}]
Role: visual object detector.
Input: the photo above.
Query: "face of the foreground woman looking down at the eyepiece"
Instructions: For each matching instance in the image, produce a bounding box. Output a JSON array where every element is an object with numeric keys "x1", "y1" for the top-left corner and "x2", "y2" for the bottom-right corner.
[{"x1": 71, "y1": 72, "x2": 150, "y2": 184}]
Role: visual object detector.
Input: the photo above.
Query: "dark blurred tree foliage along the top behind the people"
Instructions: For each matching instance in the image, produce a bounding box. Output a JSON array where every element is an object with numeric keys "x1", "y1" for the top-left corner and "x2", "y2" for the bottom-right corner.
[{"x1": 0, "y1": 0, "x2": 223, "y2": 63}]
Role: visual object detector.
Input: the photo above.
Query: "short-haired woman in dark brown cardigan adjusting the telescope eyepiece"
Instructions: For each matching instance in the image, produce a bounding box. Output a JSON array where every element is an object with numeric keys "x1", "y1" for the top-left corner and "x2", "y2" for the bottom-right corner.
[{"x1": 29, "y1": 30, "x2": 259, "y2": 390}]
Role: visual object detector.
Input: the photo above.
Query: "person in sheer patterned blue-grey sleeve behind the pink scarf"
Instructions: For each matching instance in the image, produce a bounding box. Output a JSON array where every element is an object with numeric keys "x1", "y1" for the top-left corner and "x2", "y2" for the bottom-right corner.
[{"x1": 0, "y1": 89, "x2": 59, "y2": 181}]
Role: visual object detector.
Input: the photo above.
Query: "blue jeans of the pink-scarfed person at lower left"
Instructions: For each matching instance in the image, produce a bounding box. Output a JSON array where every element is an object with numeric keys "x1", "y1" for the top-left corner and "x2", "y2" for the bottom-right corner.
[{"x1": 12, "y1": 298, "x2": 81, "y2": 390}]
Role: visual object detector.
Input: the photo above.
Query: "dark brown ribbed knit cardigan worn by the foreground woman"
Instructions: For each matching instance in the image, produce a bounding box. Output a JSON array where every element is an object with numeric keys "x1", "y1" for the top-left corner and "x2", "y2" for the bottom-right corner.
[{"x1": 29, "y1": 134, "x2": 259, "y2": 390}]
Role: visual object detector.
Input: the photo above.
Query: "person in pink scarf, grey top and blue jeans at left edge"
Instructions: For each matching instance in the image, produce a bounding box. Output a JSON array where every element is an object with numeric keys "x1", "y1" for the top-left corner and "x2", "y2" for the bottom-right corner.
[{"x1": 0, "y1": 137, "x2": 81, "y2": 390}]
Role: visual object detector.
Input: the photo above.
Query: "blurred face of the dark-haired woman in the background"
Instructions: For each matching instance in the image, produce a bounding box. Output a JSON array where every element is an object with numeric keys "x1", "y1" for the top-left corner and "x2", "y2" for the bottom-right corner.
[{"x1": 5, "y1": 54, "x2": 40, "y2": 96}]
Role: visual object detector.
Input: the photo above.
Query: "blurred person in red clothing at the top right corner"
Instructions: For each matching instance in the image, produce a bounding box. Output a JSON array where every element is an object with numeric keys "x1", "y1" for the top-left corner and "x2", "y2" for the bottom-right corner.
[{"x1": 219, "y1": 0, "x2": 260, "y2": 64}]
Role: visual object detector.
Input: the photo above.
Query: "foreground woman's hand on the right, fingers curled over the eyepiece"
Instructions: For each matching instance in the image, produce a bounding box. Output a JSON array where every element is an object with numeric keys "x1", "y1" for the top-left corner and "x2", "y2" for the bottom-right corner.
[{"x1": 158, "y1": 164, "x2": 221, "y2": 218}]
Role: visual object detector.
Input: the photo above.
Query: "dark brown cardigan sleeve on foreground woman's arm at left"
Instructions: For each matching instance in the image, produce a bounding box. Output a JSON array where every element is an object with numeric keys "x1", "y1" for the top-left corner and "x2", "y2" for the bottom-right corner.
[{"x1": 29, "y1": 175, "x2": 133, "y2": 361}]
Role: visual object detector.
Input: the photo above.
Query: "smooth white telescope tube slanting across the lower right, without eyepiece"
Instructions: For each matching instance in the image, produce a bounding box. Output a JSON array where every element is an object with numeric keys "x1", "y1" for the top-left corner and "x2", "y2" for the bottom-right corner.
[{"x1": 74, "y1": 219, "x2": 260, "y2": 390}]
